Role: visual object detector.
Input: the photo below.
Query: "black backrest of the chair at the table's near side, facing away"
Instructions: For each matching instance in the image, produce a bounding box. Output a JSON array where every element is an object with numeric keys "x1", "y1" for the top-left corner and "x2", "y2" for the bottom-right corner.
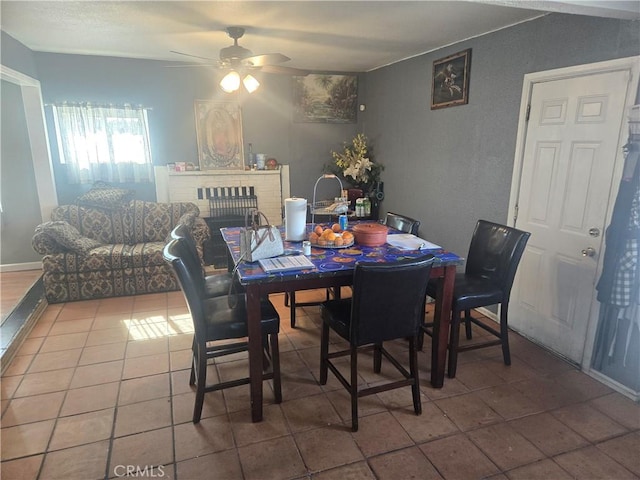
[{"x1": 351, "y1": 255, "x2": 436, "y2": 346}]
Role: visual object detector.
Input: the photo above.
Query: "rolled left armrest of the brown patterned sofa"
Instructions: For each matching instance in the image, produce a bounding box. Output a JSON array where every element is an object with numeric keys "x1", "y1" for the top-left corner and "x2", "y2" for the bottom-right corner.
[{"x1": 31, "y1": 220, "x2": 102, "y2": 255}]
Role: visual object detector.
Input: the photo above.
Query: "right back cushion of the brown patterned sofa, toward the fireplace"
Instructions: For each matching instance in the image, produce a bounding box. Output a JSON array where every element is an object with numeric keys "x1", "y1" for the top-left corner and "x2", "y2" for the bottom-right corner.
[{"x1": 127, "y1": 200, "x2": 200, "y2": 244}]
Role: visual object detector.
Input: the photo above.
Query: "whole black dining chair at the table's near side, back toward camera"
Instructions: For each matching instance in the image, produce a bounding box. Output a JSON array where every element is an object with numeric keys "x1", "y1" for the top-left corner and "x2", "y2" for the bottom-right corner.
[{"x1": 320, "y1": 255, "x2": 436, "y2": 432}]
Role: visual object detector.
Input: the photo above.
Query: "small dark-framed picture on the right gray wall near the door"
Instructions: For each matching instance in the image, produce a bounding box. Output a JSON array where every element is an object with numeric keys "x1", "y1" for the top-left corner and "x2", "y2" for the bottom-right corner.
[{"x1": 431, "y1": 48, "x2": 471, "y2": 110}]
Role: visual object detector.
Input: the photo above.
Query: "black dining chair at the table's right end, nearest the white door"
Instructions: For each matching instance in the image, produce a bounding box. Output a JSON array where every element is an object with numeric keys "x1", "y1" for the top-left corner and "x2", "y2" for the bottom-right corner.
[{"x1": 421, "y1": 220, "x2": 531, "y2": 378}]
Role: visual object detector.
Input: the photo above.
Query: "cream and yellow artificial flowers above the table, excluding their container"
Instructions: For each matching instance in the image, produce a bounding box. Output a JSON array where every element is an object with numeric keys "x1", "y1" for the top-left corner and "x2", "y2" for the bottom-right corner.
[{"x1": 329, "y1": 133, "x2": 384, "y2": 192}]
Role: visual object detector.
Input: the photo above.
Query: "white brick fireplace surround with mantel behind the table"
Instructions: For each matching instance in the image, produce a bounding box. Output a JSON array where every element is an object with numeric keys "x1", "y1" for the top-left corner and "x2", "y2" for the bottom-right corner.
[{"x1": 155, "y1": 165, "x2": 290, "y2": 225}]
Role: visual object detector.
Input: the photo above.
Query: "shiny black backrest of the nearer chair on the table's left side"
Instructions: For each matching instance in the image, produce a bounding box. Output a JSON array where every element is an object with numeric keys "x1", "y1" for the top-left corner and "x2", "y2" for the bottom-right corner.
[{"x1": 163, "y1": 238, "x2": 205, "y2": 335}]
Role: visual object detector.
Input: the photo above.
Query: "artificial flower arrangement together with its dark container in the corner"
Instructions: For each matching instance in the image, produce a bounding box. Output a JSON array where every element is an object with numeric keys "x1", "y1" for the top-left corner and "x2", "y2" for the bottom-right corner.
[{"x1": 325, "y1": 133, "x2": 384, "y2": 219}]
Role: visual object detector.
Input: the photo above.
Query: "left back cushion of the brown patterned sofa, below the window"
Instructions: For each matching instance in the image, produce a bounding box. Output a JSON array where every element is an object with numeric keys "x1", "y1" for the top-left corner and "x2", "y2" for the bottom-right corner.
[{"x1": 51, "y1": 205, "x2": 129, "y2": 244}]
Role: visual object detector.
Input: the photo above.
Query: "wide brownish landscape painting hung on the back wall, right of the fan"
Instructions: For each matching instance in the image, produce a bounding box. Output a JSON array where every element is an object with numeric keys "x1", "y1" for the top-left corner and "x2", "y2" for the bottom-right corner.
[{"x1": 293, "y1": 74, "x2": 358, "y2": 123}]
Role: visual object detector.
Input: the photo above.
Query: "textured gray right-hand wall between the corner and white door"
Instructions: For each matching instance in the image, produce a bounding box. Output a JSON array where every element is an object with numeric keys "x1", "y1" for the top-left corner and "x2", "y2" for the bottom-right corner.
[{"x1": 363, "y1": 14, "x2": 640, "y2": 255}]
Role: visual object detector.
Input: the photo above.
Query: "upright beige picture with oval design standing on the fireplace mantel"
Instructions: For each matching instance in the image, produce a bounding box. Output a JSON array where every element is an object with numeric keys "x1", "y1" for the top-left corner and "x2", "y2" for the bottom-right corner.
[{"x1": 195, "y1": 100, "x2": 244, "y2": 170}]
